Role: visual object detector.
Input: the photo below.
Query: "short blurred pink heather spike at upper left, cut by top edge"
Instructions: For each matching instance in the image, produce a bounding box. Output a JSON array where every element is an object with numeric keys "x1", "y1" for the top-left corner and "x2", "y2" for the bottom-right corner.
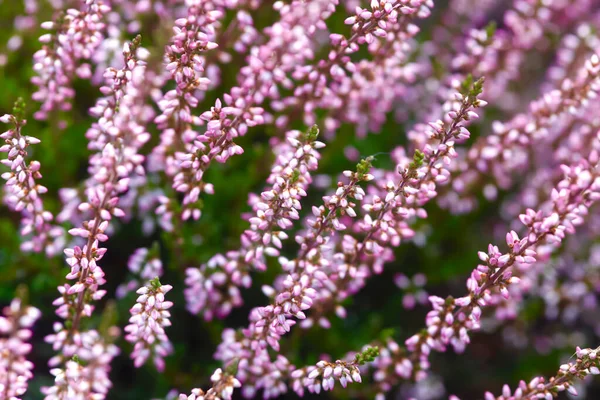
[{"x1": 31, "y1": 0, "x2": 110, "y2": 119}]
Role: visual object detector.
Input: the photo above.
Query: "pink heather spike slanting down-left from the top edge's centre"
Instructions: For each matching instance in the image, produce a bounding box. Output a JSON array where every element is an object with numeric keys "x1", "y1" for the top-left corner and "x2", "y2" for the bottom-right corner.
[{"x1": 173, "y1": 0, "x2": 337, "y2": 220}]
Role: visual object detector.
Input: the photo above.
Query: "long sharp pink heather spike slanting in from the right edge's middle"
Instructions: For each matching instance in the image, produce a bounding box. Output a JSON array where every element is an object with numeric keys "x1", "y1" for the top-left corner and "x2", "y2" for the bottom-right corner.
[{"x1": 376, "y1": 151, "x2": 600, "y2": 389}]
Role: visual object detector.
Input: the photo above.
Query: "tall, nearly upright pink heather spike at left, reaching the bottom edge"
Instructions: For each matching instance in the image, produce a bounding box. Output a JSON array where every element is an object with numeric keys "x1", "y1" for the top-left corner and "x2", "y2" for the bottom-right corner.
[{"x1": 39, "y1": 33, "x2": 149, "y2": 399}]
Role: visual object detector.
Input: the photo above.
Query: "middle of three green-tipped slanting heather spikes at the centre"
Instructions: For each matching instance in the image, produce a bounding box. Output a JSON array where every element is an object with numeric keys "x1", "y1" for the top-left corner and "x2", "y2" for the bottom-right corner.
[{"x1": 216, "y1": 159, "x2": 373, "y2": 398}]
